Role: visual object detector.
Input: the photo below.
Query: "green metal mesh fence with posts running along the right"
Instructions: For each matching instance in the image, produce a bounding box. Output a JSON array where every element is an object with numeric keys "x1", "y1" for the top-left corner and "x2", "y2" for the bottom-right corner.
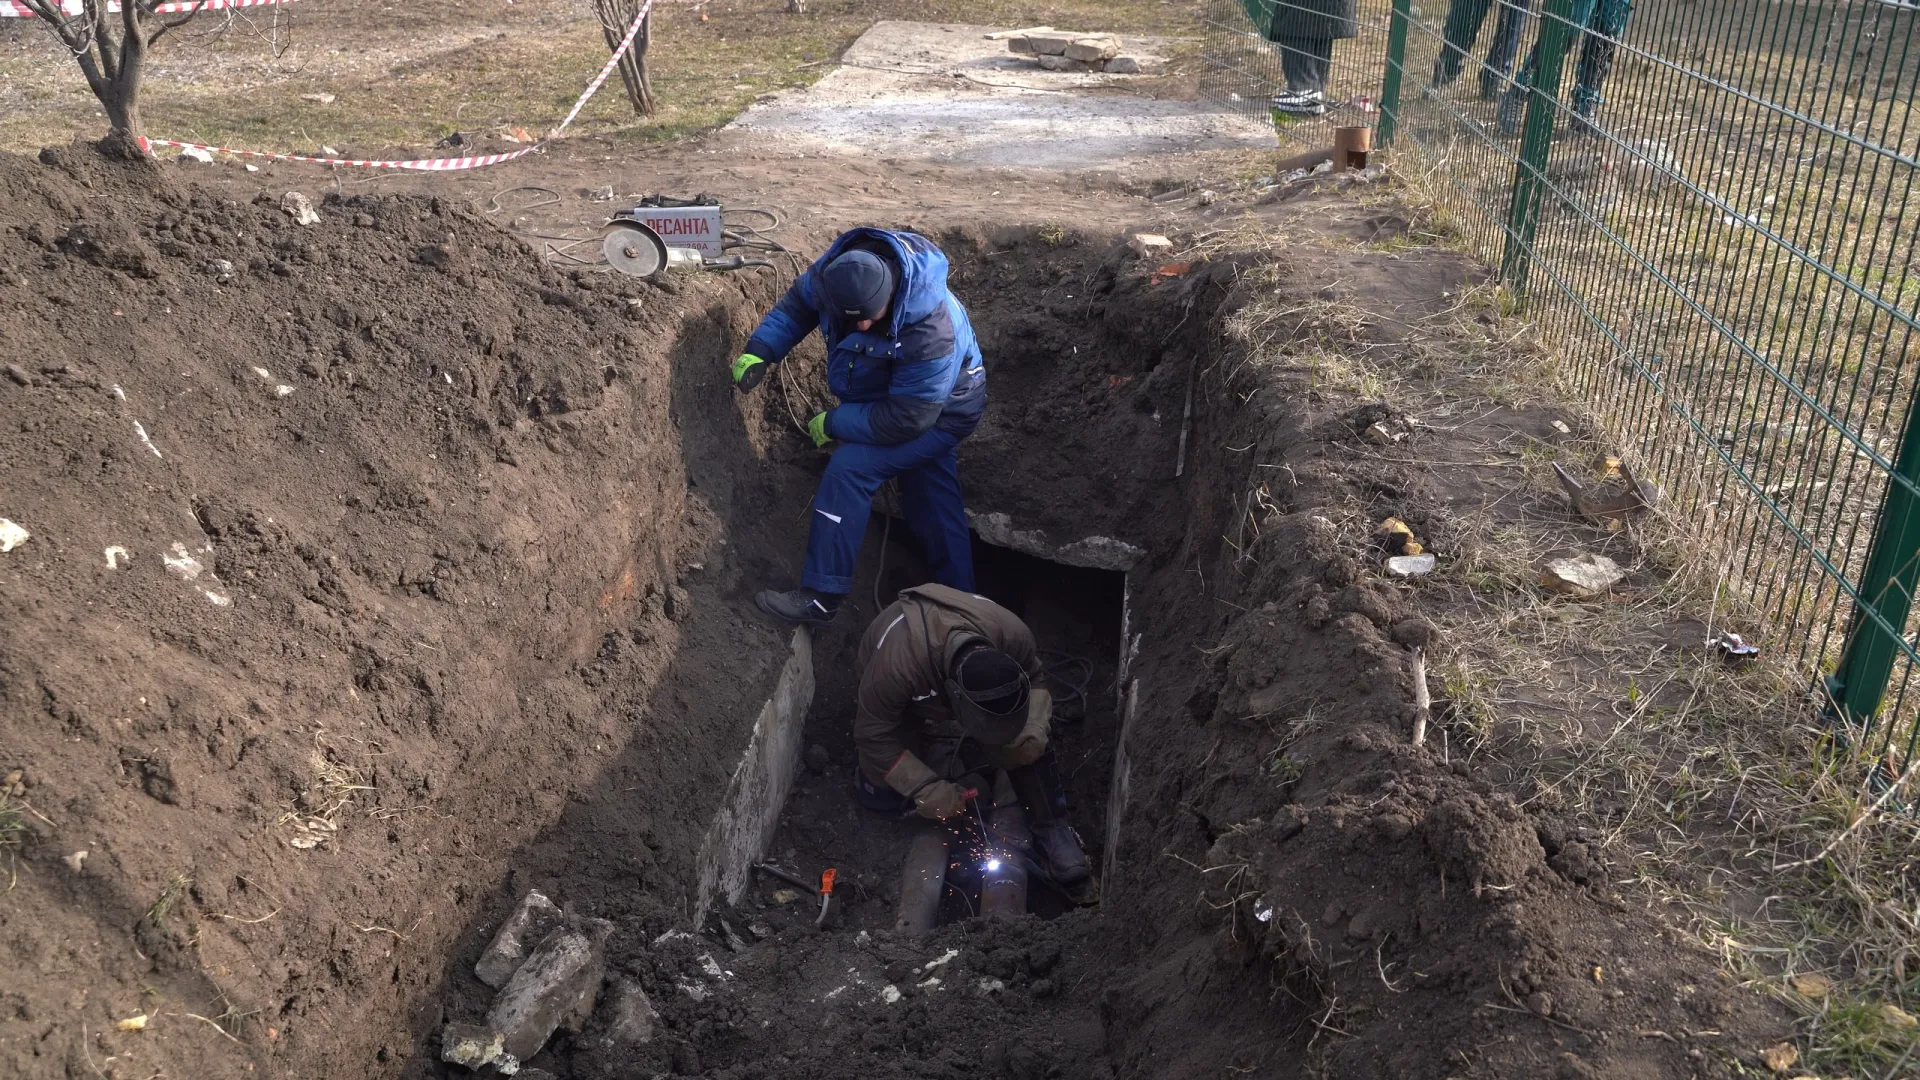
[{"x1": 1204, "y1": 0, "x2": 1920, "y2": 778}]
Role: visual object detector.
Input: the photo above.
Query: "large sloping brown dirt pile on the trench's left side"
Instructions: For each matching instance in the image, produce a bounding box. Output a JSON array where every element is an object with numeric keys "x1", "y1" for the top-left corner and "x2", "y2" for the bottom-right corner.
[{"x1": 0, "y1": 148, "x2": 806, "y2": 1076}]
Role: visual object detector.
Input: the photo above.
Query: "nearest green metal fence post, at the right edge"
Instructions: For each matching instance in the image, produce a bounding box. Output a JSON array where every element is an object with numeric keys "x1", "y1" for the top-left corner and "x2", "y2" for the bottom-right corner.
[{"x1": 1828, "y1": 396, "x2": 1920, "y2": 740}]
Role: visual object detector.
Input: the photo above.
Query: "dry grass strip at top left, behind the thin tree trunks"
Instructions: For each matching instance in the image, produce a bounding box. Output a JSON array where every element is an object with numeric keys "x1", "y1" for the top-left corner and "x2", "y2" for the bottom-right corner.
[{"x1": 0, "y1": 0, "x2": 1192, "y2": 154}]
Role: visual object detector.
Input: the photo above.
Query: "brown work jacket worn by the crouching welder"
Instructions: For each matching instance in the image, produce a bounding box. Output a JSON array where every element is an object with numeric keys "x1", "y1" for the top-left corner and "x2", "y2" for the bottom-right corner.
[{"x1": 852, "y1": 584, "x2": 1044, "y2": 786}]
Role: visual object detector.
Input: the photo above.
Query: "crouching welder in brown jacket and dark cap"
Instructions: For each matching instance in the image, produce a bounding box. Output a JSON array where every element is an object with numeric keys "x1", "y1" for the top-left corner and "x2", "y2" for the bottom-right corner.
[{"x1": 852, "y1": 584, "x2": 1092, "y2": 892}]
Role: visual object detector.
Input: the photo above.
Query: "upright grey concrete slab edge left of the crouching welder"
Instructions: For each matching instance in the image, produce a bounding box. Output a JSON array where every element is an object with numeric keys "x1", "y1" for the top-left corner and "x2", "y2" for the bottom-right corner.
[{"x1": 693, "y1": 626, "x2": 814, "y2": 926}]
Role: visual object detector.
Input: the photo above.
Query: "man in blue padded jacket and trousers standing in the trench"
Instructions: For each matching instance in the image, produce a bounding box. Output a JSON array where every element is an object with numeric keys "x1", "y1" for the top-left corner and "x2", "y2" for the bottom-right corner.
[{"x1": 733, "y1": 229, "x2": 987, "y2": 625}]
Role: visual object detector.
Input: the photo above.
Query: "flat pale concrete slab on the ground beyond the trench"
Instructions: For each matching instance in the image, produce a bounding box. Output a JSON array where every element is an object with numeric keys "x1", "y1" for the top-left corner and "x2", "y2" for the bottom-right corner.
[{"x1": 722, "y1": 21, "x2": 1275, "y2": 169}]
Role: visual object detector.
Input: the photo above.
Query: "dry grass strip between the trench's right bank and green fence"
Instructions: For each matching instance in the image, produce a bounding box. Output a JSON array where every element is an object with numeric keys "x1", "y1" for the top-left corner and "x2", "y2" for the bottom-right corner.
[{"x1": 1320, "y1": 245, "x2": 1920, "y2": 1076}]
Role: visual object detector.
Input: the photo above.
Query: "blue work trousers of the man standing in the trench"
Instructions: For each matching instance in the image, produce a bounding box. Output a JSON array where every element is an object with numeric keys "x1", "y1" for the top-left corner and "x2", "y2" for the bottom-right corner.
[{"x1": 801, "y1": 430, "x2": 973, "y2": 596}]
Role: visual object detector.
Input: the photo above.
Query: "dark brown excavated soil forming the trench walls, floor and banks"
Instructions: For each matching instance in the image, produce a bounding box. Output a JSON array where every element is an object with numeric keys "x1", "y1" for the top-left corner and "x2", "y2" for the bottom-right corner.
[{"x1": 0, "y1": 150, "x2": 1784, "y2": 1080}]
